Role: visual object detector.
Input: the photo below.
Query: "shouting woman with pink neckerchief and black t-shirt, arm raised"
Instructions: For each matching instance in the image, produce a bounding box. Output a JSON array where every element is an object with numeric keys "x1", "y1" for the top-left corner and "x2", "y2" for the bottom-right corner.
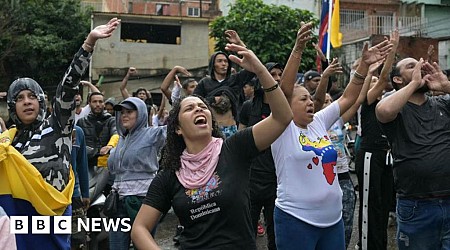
[{"x1": 131, "y1": 44, "x2": 292, "y2": 249}]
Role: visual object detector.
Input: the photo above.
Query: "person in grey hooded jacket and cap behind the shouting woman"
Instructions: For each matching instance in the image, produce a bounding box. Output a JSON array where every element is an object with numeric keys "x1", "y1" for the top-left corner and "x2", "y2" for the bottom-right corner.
[{"x1": 108, "y1": 97, "x2": 166, "y2": 250}]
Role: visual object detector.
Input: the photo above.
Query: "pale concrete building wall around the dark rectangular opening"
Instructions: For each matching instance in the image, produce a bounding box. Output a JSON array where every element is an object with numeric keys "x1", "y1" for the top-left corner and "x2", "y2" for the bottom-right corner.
[{"x1": 91, "y1": 13, "x2": 209, "y2": 81}]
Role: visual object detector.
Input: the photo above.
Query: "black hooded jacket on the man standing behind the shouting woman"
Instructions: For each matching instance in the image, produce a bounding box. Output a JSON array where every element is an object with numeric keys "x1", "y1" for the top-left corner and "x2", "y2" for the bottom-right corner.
[{"x1": 194, "y1": 51, "x2": 255, "y2": 118}]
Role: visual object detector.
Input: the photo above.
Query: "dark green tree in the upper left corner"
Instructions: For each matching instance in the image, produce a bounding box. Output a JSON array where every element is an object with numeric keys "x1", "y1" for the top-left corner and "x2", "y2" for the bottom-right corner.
[{"x1": 0, "y1": 0, "x2": 90, "y2": 92}]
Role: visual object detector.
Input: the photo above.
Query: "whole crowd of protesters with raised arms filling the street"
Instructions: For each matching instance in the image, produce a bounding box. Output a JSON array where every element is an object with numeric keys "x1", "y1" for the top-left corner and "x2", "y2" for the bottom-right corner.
[{"x1": 0, "y1": 18, "x2": 450, "y2": 250}]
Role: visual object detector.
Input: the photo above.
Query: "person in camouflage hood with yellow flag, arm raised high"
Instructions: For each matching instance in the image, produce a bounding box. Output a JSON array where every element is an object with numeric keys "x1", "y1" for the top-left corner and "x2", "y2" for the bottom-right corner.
[{"x1": 0, "y1": 18, "x2": 120, "y2": 249}]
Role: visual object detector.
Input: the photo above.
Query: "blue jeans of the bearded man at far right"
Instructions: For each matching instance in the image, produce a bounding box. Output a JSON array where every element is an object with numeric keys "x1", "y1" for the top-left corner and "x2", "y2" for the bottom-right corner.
[{"x1": 397, "y1": 197, "x2": 450, "y2": 250}]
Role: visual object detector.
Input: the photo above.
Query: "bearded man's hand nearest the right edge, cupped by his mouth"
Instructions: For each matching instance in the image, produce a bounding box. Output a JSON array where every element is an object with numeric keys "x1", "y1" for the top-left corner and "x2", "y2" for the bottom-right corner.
[{"x1": 424, "y1": 62, "x2": 450, "y2": 93}]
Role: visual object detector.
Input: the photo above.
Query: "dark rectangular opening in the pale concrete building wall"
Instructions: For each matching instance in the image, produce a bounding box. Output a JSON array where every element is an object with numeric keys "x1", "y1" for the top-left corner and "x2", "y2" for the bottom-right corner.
[{"x1": 120, "y1": 23, "x2": 181, "y2": 44}]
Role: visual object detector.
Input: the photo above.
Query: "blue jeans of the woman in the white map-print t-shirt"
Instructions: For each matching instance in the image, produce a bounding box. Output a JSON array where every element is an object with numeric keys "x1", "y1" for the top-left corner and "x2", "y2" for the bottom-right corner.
[{"x1": 274, "y1": 206, "x2": 345, "y2": 250}]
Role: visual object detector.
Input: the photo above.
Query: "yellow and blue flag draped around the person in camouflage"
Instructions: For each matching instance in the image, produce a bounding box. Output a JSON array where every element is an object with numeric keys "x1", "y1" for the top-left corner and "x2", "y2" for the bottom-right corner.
[{"x1": 0, "y1": 129, "x2": 74, "y2": 250}]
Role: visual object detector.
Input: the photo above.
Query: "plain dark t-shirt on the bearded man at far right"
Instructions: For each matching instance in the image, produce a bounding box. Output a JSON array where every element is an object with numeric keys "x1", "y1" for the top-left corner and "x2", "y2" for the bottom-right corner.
[{"x1": 381, "y1": 95, "x2": 450, "y2": 198}]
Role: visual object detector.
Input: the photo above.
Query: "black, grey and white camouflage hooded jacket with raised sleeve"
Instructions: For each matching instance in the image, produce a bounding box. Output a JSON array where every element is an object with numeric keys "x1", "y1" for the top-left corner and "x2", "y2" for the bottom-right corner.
[{"x1": 7, "y1": 48, "x2": 92, "y2": 191}]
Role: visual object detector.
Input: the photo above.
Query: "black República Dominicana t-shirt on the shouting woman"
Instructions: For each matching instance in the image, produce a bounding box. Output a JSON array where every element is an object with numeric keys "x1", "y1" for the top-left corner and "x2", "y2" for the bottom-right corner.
[{"x1": 143, "y1": 128, "x2": 258, "y2": 249}]
